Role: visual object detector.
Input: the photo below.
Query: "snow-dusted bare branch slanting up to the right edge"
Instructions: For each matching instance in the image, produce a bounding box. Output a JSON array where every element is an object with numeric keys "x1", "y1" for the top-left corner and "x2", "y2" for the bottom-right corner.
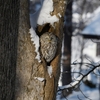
[{"x1": 58, "y1": 62, "x2": 100, "y2": 91}]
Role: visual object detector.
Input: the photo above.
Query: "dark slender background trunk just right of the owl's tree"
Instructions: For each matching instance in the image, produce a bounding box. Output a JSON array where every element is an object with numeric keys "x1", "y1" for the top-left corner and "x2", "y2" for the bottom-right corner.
[{"x1": 62, "y1": 1, "x2": 72, "y2": 95}]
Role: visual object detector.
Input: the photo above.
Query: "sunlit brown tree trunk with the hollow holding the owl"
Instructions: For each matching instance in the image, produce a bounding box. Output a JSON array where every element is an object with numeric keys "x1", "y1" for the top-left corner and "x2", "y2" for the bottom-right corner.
[{"x1": 16, "y1": 0, "x2": 66, "y2": 100}]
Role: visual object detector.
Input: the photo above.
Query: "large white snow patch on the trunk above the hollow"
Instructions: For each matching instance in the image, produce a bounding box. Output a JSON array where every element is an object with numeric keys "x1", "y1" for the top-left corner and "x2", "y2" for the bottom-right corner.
[{"x1": 37, "y1": 0, "x2": 59, "y2": 26}]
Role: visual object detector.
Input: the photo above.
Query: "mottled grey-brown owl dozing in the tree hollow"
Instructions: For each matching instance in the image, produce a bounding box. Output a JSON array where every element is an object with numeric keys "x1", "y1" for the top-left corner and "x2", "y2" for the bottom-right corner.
[{"x1": 40, "y1": 32, "x2": 57, "y2": 62}]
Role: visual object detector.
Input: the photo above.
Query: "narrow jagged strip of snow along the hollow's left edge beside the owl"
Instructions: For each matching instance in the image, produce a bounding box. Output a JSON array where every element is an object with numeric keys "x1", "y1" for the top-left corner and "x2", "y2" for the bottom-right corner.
[{"x1": 29, "y1": 27, "x2": 41, "y2": 62}]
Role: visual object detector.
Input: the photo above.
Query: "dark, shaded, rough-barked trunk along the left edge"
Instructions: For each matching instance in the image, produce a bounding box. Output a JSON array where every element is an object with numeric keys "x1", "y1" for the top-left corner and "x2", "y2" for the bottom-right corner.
[{"x1": 0, "y1": 0, "x2": 19, "y2": 100}]
